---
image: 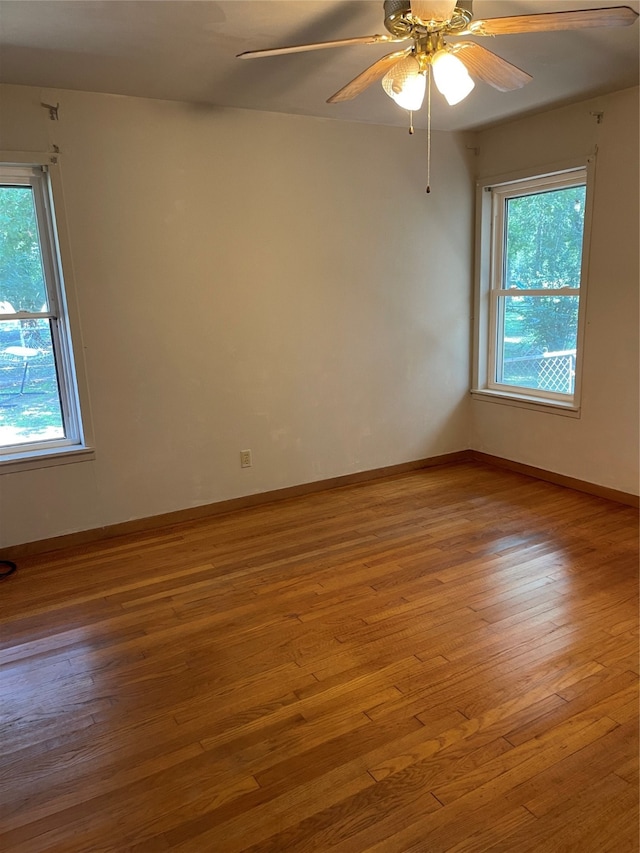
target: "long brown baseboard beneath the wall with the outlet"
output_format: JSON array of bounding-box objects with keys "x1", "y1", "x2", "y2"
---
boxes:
[{"x1": 0, "y1": 450, "x2": 471, "y2": 560}]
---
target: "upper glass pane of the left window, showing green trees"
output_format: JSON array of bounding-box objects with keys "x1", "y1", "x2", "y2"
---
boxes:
[{"x1": 0, "y1": 186, "x2": 47, "y2": 313}]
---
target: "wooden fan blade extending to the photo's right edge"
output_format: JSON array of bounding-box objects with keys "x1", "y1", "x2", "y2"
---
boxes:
[{"x1": 456, "y1": 6, "x2": 638, "y2": 36}]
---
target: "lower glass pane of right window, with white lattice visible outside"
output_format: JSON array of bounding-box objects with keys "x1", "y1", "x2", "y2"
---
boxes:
[{"x1": 496, "y1": 296, "x2": 579, "y2": 394}]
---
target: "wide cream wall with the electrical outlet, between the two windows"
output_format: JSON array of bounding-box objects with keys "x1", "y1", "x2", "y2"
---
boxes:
[{"x1": 0, "y1": 86, "x2": 473, "y2": 546}]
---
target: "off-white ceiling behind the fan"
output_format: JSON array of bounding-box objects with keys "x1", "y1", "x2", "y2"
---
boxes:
[{"x1": 0, "y1": 0, "x2": 640, "y2": 130}]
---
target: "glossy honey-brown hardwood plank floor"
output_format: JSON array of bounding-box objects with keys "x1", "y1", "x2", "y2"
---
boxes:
[{"x1": 0, "y1": 463, "x2": 638, "y2": 853}]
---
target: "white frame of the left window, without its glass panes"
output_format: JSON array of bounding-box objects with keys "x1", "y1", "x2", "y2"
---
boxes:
[{"x1": 0, "y1": 151, "x2": 94, "y2": 474}]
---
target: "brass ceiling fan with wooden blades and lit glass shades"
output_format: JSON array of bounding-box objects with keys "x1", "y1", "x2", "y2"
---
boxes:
[{"x1": 238, "y1": 0, "x2": 638, "y2": 111}]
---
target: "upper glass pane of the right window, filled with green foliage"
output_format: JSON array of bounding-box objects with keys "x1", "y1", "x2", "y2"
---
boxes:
[{"x1": 503, "y1": 186, "x2": 586, "y2": 290}]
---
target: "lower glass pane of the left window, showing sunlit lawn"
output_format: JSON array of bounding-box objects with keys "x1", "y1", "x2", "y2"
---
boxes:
[{"x1": 0, "y1": 319, "x2": 65, "y2": 447}]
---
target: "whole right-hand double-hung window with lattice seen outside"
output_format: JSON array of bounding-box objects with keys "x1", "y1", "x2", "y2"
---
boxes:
[{"x1": 474, "y1": 163, "x2": 589, "y2": 411}]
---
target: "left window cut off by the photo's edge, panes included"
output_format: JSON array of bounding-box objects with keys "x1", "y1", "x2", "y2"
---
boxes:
[{"x1": 0, "y1": 164, "x2": 90, "y2": 463}]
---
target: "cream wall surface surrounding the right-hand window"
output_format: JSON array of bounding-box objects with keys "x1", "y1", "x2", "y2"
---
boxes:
[{"x1": 471, "y1": 89, "x2": 640, "y2": 494}]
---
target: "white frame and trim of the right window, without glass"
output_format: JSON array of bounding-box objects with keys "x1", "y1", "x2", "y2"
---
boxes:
[{"x1": 471, "y1": 155, "x2": 595, "y2": 417}]
